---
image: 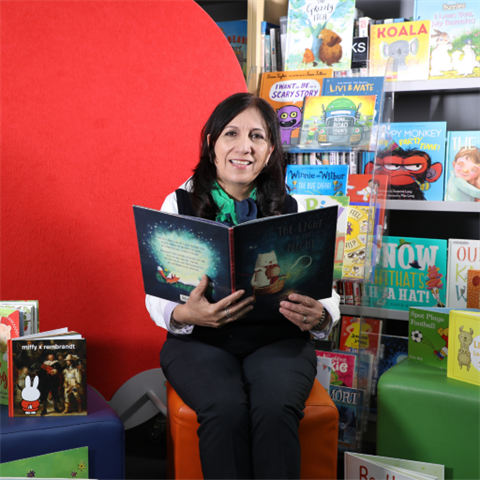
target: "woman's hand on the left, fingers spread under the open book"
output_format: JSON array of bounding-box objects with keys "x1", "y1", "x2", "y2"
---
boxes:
[{"x1": 172, "y1": 275, "x2": 253, "y2": 328}]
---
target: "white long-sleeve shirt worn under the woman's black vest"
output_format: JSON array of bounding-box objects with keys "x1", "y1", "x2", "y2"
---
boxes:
[{"x1": 145, "y1": 180, "x2": 340, "y2": 340}]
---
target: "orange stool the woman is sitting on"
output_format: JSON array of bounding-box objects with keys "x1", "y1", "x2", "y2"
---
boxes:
[{"x1": 167, "y1": 380, "x2": 338, "y2": 480}]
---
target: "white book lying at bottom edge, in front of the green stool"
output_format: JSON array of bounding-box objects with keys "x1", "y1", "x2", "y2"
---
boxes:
[{"x1": 344, "y1": 452, "x2": 445, "y2": 480}]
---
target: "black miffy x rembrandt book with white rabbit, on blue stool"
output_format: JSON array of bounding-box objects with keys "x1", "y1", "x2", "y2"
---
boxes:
[{"x1": 8, "y1": 328, "x2": 87, "y2": 418}]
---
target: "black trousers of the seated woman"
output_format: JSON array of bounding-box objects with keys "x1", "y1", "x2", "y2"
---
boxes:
[{"x1": 160, "y1": 335, "x2": 317, "y2": 480}]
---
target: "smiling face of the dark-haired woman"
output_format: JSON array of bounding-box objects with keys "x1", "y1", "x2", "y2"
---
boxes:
[{"x1": 210, "y1": 108, "x2": 273, "y2": 200}]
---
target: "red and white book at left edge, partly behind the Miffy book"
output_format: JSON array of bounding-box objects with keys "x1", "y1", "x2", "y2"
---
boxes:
[{"x1": 0, "y1": 306, "x2": 23, "y2": 405}]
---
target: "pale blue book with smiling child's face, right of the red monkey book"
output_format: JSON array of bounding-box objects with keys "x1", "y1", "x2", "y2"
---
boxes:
[{"x1": 444, "y1": 130, "x2": 480, "y2": 202}]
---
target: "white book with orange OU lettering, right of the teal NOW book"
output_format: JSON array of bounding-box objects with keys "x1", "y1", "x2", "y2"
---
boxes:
[{"x1": 447, "y1": 238, "x2": 480, "y2": 308}]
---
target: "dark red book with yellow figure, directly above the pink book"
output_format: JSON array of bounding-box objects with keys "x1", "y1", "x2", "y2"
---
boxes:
[{"x1": 338, "y1": 315, "x2": 382, "y2": 358}]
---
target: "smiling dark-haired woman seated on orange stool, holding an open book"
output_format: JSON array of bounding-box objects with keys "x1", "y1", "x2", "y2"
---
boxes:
[{"x1": 146, "y1": 93, "x2": 340, "y2": 480}]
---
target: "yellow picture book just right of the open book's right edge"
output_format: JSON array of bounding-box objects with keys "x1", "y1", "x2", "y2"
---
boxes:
[{"x1": 342, "y1": 205, "x2": 370, "y2": 280}]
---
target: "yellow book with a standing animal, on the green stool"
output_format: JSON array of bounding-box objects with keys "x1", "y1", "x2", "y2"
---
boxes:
[{"x1": 447, "y1": 310, "x2": 480, "y2": 386}]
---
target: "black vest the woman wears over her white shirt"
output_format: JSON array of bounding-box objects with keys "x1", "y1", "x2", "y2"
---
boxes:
[{"x1": 169, "y1": 189, "x2": 310, "y2": 356}]
